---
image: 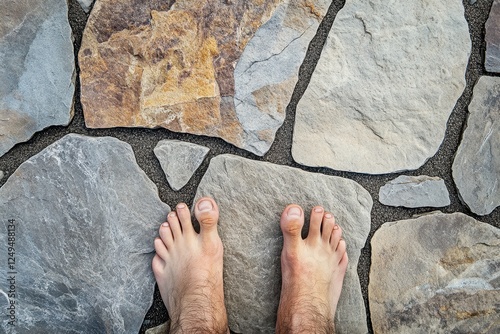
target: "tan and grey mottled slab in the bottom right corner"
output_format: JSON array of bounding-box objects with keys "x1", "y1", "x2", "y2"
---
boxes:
[{"x1": 368, "y1": 213, "x2": 500, "y2": 333}]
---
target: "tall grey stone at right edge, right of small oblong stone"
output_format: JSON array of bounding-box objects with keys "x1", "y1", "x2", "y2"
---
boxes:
[{"x1": 453, "y1": 77, "x2": 500, "y2": 215}]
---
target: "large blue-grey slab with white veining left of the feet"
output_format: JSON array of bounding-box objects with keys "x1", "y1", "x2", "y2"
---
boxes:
[{"x1": 0, "y1": 135, "x2": 169, "y2": 333}]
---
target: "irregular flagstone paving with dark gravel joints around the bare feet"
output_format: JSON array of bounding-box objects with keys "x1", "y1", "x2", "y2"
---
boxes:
[{"x1": 0, "y1": 0, "x2": 500, "y2": 333}]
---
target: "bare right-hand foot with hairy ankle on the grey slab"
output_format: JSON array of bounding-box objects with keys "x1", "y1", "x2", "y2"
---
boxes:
[{"x1": 276, "y1": 204, "x2": 348, "y2": 333}]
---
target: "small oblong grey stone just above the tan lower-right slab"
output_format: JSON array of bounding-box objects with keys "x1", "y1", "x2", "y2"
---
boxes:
[{"x1": 378, "y1": 175, "x2": 450, "y2": 208}]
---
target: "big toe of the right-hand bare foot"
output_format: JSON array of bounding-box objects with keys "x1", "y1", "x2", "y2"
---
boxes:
[{"x1": 280, "y1": 204, "x2": 304, "y2": 248}]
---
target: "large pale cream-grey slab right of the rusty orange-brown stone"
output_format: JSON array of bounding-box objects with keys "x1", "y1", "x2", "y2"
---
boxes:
[{"x1": 292, "y1": 0, "x2": 471, "y2": 174}]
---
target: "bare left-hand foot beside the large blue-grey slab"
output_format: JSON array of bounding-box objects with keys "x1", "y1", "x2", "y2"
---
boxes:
[{"x1": 153, "y1": 197, "x2": 229, "y2": 333}]
